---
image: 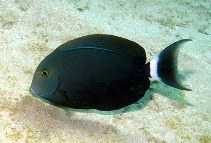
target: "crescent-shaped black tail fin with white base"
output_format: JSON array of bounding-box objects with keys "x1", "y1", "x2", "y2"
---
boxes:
[{"x1": 150, "y1": 39, "x2": 191, "y2": 90}]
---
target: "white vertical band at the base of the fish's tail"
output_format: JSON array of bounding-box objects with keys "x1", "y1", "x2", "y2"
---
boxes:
[{"x1": 150, "y1": 56, "x2": 161, "y2": 81}]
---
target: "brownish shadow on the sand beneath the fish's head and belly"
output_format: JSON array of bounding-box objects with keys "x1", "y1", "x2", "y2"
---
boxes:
[{"x1": 12, "y1": 95, "x2": 125, "y2": 142}]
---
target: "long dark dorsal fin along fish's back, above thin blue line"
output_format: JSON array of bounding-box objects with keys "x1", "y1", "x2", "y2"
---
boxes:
[{"x1": 55, "y1": 34, "x2": 146, "y2": 64}]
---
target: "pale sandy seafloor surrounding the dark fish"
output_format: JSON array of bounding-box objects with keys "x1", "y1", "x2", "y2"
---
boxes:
[{"x1": 0, "y1": 0, "x2": 211, "y2": 143}]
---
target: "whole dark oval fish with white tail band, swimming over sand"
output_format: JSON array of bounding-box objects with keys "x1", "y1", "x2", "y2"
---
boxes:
[{"x1": 29, "y1": 34, "x2": 191, "y2": 111}]
